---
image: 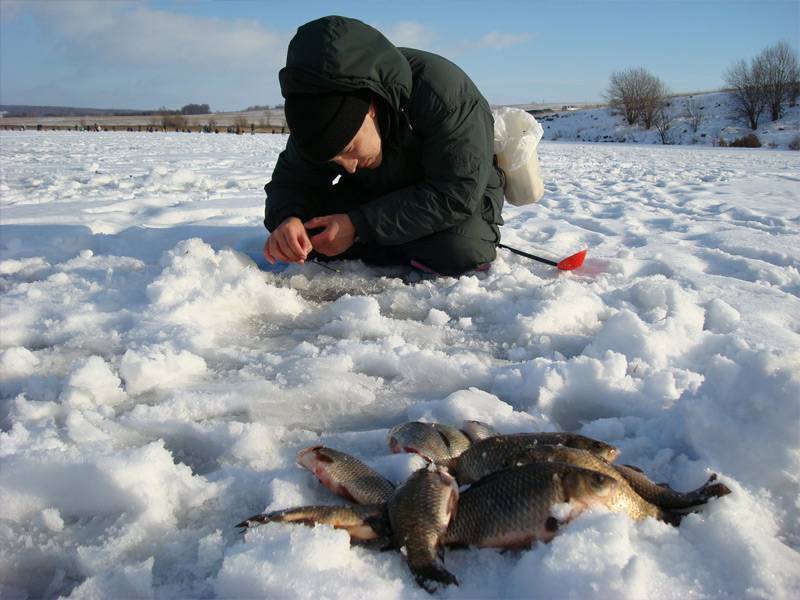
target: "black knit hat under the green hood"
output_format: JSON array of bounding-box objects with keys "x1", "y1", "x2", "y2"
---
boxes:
[{"x1": 284, "y1": 90, "x2": 372, "y2": 162}]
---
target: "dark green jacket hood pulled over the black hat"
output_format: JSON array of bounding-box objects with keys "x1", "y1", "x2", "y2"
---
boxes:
[{"x1": 278, "y1": 16, "x2": 412, "y2": 110}]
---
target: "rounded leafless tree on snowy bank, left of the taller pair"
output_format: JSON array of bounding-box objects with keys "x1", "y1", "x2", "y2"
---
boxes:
[{"x1": 606, "y1": 67, "x2": 667, "y2": 129}]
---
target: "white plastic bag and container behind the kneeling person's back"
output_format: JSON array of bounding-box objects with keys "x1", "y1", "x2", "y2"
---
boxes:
[{"x1": 492, "y1": 107, "x2": 544, "y2": 206}]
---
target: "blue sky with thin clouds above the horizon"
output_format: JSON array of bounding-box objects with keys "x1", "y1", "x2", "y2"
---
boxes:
[{"x1": 0, "y1": 0, "x2": 800, "y2": 110}]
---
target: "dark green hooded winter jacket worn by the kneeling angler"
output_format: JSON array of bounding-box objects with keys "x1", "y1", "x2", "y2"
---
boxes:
[{"x1": 264, "y1": 16, "x2": 503, "y2": 246}]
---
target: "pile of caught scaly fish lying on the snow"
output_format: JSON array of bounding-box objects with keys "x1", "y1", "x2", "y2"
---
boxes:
[{"x1": 238, "y1": 421, "x2": 730, "y2": 591}]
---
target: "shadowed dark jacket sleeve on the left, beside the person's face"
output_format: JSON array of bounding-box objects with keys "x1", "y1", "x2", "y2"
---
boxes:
[{"x1": 264, "y1": 136, "x2": 336, "y2": 231}]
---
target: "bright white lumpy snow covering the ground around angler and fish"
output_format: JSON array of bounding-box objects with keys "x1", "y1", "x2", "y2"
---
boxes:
[{"x1": 0, "y1": 132, "x2": 800, "y2": 600}]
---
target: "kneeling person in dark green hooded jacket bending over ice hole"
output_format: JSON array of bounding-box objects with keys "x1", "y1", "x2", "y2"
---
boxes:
[{"x1": 264, "y1": 17, "x2": 504, "y2": 275}]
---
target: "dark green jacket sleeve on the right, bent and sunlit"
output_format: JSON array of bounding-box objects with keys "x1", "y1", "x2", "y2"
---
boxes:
[{"x1": 348, "y1": 85, "x2": 494, "y2": 245}]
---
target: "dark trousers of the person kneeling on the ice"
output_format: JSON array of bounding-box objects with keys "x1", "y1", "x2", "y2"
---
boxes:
[{"x1": 319, "y1": 184, "x2": 500, "y2": 275}]
